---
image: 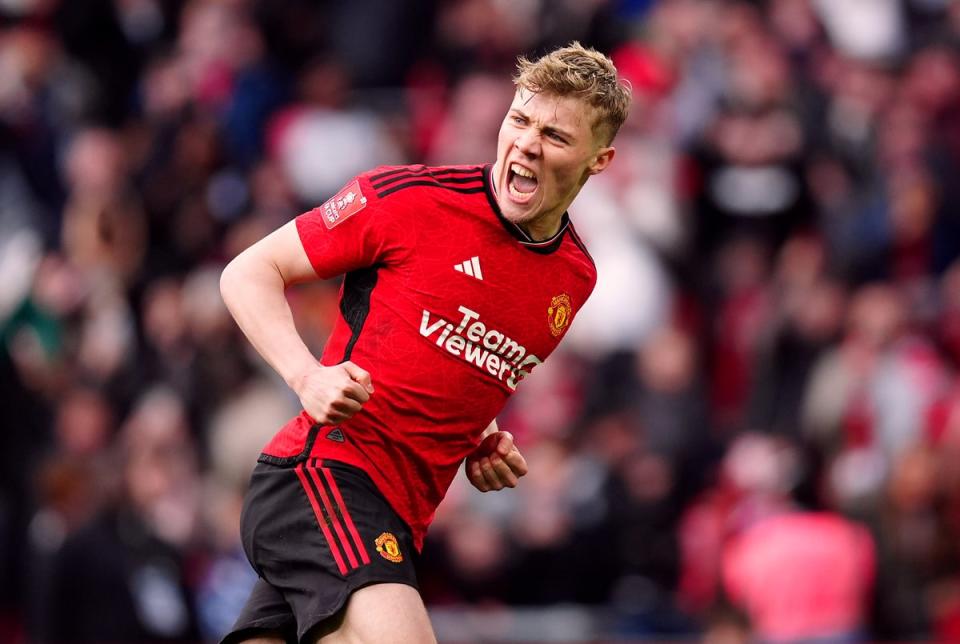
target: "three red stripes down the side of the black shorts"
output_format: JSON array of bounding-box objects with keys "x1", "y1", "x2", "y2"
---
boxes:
[{"x1": 295, "y1": 458, "x2": 370, "y2": 575}]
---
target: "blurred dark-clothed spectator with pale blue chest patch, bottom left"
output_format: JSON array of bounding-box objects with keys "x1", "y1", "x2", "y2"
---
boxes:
[{"x1": 41, "y1": 390, "x2": 198, "y2": 642}]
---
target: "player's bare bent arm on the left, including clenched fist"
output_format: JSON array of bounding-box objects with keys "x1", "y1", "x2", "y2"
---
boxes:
[{"x1": 220, "y1": 221, "x2": 373, "y2": 425}]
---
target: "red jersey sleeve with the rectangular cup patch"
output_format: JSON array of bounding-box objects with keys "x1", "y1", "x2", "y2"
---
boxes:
[{"x1": 296, "y1": 175, "x2": 399, "y2": 279}]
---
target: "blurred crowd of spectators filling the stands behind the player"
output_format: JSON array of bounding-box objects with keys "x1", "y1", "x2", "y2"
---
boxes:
[{"x1": 0, "y1": 0, "x2": 960, "y2": 643}]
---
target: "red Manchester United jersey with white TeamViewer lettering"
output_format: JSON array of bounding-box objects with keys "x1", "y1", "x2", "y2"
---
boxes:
[{"x1": 264, "y1": 165, "x2": 596, "y2": 548}]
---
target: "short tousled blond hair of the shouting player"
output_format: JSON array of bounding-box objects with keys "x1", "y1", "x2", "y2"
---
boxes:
[{"x1": 513, "y1": 41, "x2": 630, "y2": 145}]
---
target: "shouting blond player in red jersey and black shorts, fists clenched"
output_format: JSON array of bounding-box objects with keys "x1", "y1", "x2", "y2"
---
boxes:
[{"x1": 221, "y1": 43, "x2": 630, "y2": 644}]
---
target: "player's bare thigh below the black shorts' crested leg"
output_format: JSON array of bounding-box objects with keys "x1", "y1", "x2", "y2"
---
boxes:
[{"x1": 310, "y1": 584, "x2": 437, "y2": 644}]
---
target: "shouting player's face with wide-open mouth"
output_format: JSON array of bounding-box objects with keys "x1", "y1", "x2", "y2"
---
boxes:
[{"x1": 493, "y1": 88, "x2": 614, "y2": 239}]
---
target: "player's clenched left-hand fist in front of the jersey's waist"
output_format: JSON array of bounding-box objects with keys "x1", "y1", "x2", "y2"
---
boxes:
[{"x1": 294, "y1": 362, "x2": 373, "y2": 425}]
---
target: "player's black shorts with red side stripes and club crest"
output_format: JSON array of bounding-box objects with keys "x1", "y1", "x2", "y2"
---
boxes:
[{"x1": 222, "y1": 458, "x2": 417, "y2": 644}]
